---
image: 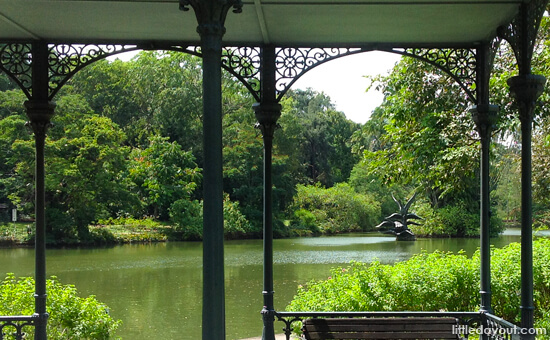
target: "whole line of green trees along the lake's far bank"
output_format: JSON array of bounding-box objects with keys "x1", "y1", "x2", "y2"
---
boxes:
[{"x1": 0, "y1": 18, "x2": 550, "y2": 241}]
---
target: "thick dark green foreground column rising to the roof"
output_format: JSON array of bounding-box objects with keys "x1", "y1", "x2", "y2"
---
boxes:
[{"x1": 180, "y1": 0, "x2": 242, "y2": 340}]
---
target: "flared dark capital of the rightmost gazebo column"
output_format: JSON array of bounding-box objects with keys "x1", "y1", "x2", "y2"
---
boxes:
[{"x1": 508, "y1": 74, "x2": 546, "y2": 123}]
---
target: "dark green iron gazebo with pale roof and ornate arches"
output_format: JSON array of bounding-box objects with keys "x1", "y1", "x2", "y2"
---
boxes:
[{"x1": 0, "y1": 0, "x2": 547, "y2": 340}]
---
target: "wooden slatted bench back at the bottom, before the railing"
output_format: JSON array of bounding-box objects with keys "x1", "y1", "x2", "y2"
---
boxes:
[{"x1": 302, "y1": 317, "x2": 461, "y2": 340}]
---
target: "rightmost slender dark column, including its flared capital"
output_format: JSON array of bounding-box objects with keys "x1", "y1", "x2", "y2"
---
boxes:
[{"x1": 508, "y1": 74, "x2": 546, "y2": 339}]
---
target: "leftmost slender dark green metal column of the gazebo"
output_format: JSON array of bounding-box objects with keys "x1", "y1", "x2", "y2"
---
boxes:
[{"x1": 25, "y1": 42, "x2": 55, "y2": 340}]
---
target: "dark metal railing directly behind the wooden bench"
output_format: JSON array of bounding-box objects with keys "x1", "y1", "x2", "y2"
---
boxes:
[{"x1": 275, "y1": 312, "x2": 484, "y2": 340}]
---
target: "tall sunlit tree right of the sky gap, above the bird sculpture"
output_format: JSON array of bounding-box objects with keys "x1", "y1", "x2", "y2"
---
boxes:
[{"x1": 356, "y1": 58, "x2": 479, "y2": 207}]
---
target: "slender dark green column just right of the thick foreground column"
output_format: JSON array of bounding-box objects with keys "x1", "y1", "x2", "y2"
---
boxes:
[{"x1": 254, "y1": 46, "x2": 281, "y2": 340}]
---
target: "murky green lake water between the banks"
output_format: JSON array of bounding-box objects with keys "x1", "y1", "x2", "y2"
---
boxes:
[{"x1": 0, "y1": 229, "x2": 544, "y2": 340}]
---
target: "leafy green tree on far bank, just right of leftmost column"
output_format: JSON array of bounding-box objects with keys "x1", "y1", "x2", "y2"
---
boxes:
[{"x1": 46, "y1": 95, "x2": 137, "y2": 240}]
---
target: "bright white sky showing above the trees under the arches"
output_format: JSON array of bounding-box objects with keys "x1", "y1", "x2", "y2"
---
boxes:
[{"x1": 109, "y1": 52, "x2": 401, "y2": 123}]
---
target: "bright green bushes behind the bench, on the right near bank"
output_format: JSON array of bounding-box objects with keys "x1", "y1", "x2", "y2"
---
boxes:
[{"x1": 287, "y1": 239, "x2": 550, "y2": 325}]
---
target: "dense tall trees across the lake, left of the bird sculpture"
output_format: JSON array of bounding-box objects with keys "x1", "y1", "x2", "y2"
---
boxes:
[{"x1": 0, "y1": 52, "x2": 366, "y2": 242}]
